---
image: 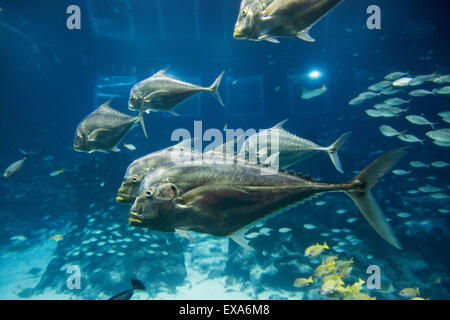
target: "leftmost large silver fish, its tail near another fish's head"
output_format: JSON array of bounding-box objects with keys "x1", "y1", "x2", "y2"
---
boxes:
[{"x1": 73, "y1": 100, "x2": 147, "y2": 153}]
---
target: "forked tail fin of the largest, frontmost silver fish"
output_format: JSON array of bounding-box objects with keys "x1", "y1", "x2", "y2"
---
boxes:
[{"x1": 346, "y1": 148, "x2": 406, "y2": 249}]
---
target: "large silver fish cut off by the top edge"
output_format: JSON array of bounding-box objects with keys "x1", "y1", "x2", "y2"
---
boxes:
[{"x1": 233, "y1": 0, "x2": 341, "y2": 43}]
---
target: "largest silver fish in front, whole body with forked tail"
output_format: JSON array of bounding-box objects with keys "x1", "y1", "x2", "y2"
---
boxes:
[{"x1": 128, "y1": 148, "x2": 406, "y2": 248}]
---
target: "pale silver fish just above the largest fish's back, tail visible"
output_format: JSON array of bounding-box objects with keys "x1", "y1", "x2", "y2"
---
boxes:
[{"x1": 238, "y1": 120, "x2": 350, "y2": 173}]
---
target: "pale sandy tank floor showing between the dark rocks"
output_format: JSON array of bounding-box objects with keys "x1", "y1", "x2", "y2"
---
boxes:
[{"x1": 0, "y1": 237, "x2": 303, "y2": 300}]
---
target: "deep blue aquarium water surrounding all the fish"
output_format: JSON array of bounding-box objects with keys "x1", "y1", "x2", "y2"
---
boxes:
[{"x1": 0, "y1": 0, "x2": 450, "y2": 299}]
